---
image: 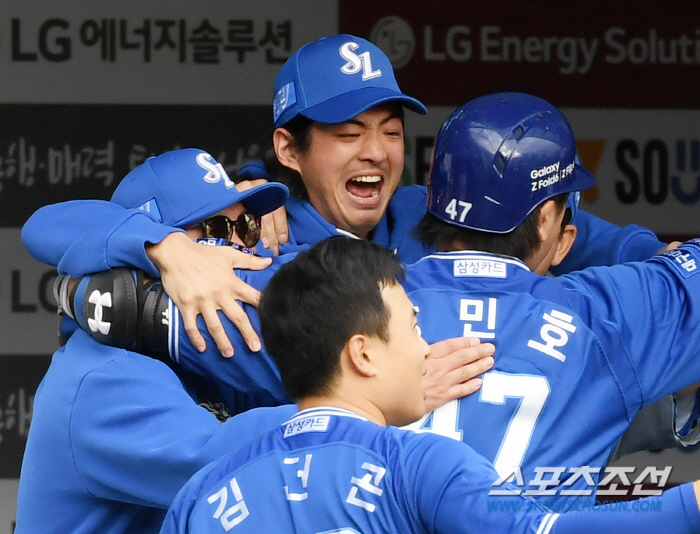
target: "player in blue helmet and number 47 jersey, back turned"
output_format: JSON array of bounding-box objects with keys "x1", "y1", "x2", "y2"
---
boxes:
[{"x1": 405, "y1": 93, "x2": 700, "y2": 500}]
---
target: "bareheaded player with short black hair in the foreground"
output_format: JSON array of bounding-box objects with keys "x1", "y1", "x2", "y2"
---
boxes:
[{"x1": 161, "y1": 239, "x2": 700, "y2": 534}]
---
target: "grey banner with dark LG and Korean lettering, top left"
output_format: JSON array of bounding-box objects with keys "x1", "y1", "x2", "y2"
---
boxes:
[{"x1": 0, "y1": 0, "x2": 337, "y2": 104}]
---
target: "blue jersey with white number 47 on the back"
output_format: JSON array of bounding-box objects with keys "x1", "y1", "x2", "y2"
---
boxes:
[{"x1": 405, "y1": 241, "x2": 700, "y2": 498}]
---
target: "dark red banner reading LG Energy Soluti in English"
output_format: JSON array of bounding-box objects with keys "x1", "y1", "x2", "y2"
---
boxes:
[{"x1": 340, "y1": 0, "x2": 700, "y2": 108}]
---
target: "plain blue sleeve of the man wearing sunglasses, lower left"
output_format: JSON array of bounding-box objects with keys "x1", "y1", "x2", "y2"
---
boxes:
[{"x1": 70, "y1": 340, "x2": 295, "y2": 508}]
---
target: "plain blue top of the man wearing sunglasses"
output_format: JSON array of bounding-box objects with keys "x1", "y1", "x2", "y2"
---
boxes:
[{"x1": 15, "y1": 330, "x2": 296, "y2": 534}]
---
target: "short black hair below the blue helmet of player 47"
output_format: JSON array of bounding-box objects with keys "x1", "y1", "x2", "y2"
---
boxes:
[{"x1": 415, "y1": 193, "x2": 571, "y2": 261}]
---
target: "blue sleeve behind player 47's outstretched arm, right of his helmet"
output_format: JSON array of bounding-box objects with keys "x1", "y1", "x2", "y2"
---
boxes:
[{"x1": 550, "y1": 210, "x2": 666, "y2": 275}]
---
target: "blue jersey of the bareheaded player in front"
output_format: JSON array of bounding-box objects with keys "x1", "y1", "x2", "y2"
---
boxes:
[{"x1": 161, "y1": 407, "x2": 700, "y2": 534}]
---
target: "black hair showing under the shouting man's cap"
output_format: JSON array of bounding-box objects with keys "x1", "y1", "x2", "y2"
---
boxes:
[{"x1": 265, "y1": 101, "x2": 405, "y2": 201}]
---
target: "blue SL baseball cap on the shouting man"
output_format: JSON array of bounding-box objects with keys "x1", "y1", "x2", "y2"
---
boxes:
[{"x1": 272, "y1": 34, "x2": 428, "y2": 128}]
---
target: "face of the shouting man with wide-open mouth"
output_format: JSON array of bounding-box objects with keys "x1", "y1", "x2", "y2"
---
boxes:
[{"x1": 278, "y1": 104, "x2": 404, "y2": 238}]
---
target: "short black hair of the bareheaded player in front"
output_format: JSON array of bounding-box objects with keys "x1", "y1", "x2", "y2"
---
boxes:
[{"x1": 258, "y1": 236, "x2": 404, "y2": 401}]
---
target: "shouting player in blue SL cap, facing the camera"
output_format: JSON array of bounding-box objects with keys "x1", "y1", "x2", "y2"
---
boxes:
[{"x1": 24, "y1": 35, "x2": 426, "y2": 355}]
